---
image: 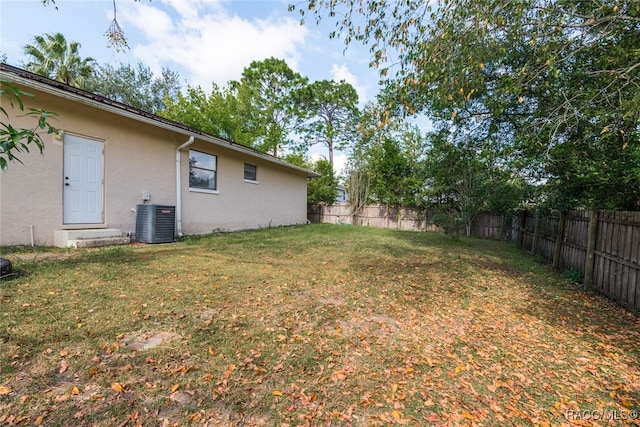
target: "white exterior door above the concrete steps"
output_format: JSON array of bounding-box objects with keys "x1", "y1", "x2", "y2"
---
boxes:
[{"x1": 63, "y1": 135, "x2": 104, "y2": 224}]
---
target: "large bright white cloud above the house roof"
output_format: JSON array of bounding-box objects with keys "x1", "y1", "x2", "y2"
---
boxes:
[{"x1": 122, "y1": 0, "x2": 309, "y2": 90}]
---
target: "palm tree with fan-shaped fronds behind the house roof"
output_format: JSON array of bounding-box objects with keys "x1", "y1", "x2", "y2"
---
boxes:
[{"x1": 24, "y1": 33, "x2": 95, "y2": 88}]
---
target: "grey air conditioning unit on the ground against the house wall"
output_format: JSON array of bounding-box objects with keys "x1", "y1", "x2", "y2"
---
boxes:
[{"x1": 136, "y1": 205, "x2": 176, "y2": 243}]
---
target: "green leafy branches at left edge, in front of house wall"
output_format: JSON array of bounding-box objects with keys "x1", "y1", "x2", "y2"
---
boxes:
[{"x1": 0, "y1": 81, "x2": 56, "y2": 172}]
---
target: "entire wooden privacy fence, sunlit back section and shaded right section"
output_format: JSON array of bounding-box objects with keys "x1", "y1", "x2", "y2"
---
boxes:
[{"x1": 308, "y1": 203, "x2": 640, "y2": 313}]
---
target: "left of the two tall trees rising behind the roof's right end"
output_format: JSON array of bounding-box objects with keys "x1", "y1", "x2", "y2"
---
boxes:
[{"x1": 230, "y1": 58, "x2": 307, "y2": 156}]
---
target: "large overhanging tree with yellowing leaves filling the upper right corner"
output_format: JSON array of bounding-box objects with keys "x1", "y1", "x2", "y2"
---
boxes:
[{"x1": 292, "y1": 0, "x2": 640, "y2": 211}]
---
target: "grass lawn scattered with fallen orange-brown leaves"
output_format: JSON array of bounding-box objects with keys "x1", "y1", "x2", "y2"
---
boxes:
[{"x1": 0, "y1": 224, "x2": 640, "y2": 426}]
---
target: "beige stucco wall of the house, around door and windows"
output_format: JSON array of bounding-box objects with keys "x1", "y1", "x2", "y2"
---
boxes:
[{"x1": 0, "y1": 82, "x2": 306, "y2": 245}]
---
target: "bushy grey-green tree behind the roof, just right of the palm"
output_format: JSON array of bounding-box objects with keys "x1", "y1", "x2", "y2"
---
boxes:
[{"x1": 87, "y1": 62, "x2": 180, "y2": 114}]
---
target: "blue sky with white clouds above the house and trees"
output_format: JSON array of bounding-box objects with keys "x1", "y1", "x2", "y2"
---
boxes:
[{"x1": 0, "y1": 0, "x2": 378, "y2": 172}]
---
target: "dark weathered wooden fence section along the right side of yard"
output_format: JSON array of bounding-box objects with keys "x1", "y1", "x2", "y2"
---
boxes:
[{"x1": 514, "y1": 211, "x2": 640, "y2": 313}]
